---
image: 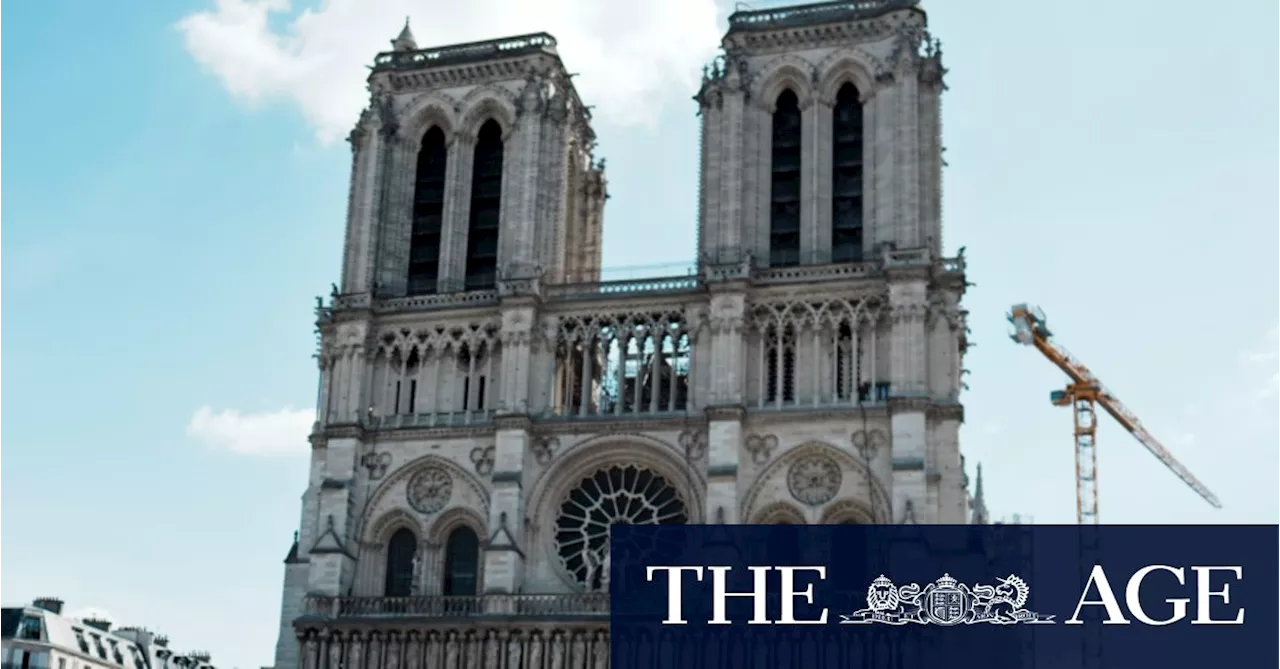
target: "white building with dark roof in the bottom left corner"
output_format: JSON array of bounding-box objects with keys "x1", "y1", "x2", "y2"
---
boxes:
[{"x1": 0, "y1": 597, "x2": 214, "y2": 669}]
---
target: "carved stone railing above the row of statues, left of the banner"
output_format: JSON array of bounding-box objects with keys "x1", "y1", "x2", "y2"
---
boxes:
[{"x1": 303, "y1": 592, "x2": 609, "y2": 619}]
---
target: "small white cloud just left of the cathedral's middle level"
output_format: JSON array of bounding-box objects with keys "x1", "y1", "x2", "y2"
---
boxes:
[{"x1": 187, "y1": 407, "x2": 315, "y2": 455}]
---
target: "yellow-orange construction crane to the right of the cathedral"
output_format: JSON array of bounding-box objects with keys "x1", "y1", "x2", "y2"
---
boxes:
[{"x1": 1009, "y1": 304, "x2": 1222, "y2": 524}]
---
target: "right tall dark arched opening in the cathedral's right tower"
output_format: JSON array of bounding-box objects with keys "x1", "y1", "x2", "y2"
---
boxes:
[{"x1": 831, "y1": 83, "x2": 863, "y2": 262}]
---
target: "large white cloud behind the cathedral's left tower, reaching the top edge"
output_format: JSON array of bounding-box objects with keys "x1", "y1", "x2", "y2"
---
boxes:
[{"x1": 177, "y1": 0, "x2": 722, "y2": 142}]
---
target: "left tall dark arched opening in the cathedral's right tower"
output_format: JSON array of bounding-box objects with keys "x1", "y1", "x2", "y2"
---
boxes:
[{"x1": 769, "y1": 88, "x2": 800, "y2": 267}]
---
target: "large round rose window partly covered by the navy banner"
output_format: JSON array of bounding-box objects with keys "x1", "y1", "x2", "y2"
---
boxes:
[{"x1": 556, "y1": 464, "x2": 689, "y2": 586}]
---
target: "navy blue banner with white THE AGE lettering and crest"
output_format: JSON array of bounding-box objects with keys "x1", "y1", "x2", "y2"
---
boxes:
[{"x1": 609, "y1": 524, "x2": 1280, "y2": 669}]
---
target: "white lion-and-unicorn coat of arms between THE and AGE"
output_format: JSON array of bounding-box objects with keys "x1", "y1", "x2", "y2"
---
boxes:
[{"x1": 841, "y1": 574, "x2": 1053, "y2": 627}]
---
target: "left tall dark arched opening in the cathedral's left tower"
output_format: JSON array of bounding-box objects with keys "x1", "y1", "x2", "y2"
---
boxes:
[{"x1": 408, "y1": 125, "x2": 448, "y2": 295}]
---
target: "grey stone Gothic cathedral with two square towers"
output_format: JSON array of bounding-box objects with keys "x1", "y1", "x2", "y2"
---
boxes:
[{"x1": 275, "y1": 0, "x2": 986, "y2": 669}]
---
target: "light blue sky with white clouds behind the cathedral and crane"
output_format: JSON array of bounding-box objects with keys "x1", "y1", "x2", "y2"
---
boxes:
[{"x1": 0, "y1": 0, "x2": 1280, "y2": 668}]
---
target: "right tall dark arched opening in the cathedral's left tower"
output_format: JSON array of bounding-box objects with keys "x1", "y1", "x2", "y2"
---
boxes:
[{"x1": 466, "y1": 119, "x2": 502, "y2": 290}]
